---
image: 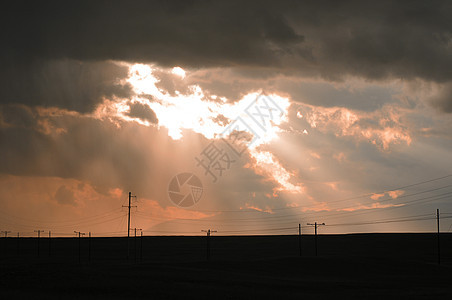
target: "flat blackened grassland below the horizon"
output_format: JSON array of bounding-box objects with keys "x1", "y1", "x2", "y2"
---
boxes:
[{"x1": 0, "y1": 233, "x2": 452, "y2": 299}]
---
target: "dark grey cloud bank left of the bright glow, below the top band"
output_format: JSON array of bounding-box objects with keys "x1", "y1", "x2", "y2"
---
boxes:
[{"x1": 0, "y1": 59, "x2": 131, "y2": 112}]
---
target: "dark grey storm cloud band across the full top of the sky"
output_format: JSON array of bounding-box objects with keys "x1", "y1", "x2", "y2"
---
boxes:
[{"x1": 1, "y1": 1, "x2": 452, "y2": 81}]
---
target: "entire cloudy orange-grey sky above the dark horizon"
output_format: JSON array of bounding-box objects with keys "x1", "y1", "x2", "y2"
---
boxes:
[{"x1": 0, "y1": 1, "x2": 452, "y2": 236}]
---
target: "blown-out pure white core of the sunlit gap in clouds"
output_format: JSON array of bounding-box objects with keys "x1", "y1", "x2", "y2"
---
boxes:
[{"x1": 128, "y1": 64, "x2": 290, "y2": 147}]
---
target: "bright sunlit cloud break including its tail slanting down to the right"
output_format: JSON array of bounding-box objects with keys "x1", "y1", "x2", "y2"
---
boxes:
[{"x1": 119, "y1": 64, "x2": 302, "y2": 193}]
